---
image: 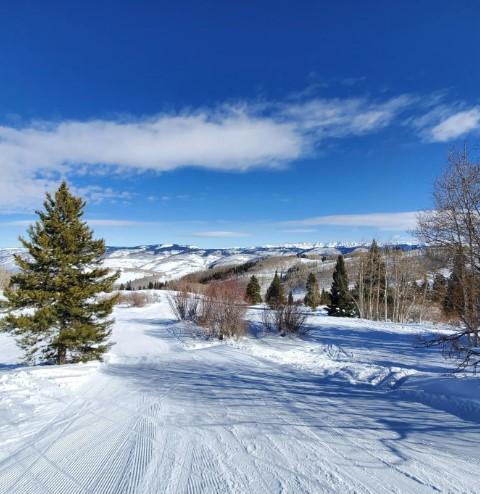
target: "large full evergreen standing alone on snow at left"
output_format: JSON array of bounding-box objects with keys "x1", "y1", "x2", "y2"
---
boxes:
[{"x1": 2, "y1": 182, "x2": 118, "y2": 364}]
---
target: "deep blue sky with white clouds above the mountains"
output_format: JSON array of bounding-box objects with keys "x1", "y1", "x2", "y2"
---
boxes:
[{"x1": 0, "y1": 0, "x2": 480, "y2": 247}]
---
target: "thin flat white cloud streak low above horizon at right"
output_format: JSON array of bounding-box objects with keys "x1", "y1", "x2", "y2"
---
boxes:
[{"x1": 283, "y1": 211, "x2": 418, "y2": 231}]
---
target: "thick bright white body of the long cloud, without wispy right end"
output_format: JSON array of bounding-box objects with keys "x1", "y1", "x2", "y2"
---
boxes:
[{"x1": 0, "y1": 110, "x2": 302, "y2": 171}]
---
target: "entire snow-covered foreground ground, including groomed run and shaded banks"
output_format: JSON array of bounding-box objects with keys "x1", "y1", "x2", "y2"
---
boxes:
[{"x1": 0, "y1": 294, "x2": 480, "y2": 494}]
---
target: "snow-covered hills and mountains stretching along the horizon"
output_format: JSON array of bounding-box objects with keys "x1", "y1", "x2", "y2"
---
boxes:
[{"x1": 0, "y1": 242, "x2": 420, "y2": 283}]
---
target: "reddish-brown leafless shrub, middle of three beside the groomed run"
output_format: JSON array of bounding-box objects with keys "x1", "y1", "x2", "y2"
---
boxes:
[{"x1": 198, "y1": 280, "x2": 247, "y2": 339}]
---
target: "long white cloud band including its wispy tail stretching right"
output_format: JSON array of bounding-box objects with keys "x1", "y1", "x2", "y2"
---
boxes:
[{"x1": 0, "y1": 96, "x2": 411, "y2": 213}]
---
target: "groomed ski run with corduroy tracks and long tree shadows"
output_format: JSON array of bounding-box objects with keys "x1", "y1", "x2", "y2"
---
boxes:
[{"x1": 0, "y1": 300, "x2": 480, "y2": 494}]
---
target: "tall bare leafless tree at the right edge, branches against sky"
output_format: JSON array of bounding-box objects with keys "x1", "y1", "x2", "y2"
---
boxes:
[{"x1": 416, "y1": 146, "x2": 480, "y2": 370}]
